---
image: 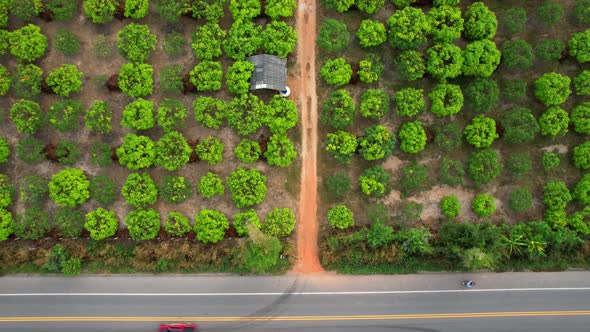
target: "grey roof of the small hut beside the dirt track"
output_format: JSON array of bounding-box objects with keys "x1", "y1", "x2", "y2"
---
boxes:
[{"x1": 246, "y1": 54, "x2": 287, "y2": 91}]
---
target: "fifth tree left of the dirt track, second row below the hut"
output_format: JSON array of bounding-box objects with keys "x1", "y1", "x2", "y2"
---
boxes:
[{"x1": 116, "y1": 134, "x2": 156, "y2": 171}]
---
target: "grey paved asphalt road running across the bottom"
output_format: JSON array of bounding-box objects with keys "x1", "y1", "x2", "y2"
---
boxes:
[{"x1": 0, "y1": 272, "x2": 590, "y2": 332}]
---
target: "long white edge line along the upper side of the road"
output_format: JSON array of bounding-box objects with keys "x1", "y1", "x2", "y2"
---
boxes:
[{"x1": 0, "y1": 287, "x2": 590, "y2": 297}]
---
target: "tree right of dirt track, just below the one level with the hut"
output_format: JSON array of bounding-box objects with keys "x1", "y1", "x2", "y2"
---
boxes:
[{"x1": 320, "y1": 89, "x2": 356, "y2": 129}]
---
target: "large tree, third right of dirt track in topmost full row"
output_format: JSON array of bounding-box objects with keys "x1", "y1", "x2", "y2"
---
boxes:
[{"x1": 387, "y1": 7, "x2": 431, "y2": 50}]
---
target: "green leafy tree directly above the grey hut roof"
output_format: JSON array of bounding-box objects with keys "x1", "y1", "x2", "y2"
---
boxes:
[{"x1": 264, "y1": 20, "x2": 297, "y2": 58}]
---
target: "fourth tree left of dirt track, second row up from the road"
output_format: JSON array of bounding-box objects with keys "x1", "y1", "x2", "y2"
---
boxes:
[{"x1": 121, "y1": 173, "x2": 158, "y2": 208}]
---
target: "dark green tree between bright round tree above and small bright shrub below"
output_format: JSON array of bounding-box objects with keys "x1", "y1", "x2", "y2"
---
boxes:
[{"x1": 467, "y1": 149, "x2": 502, "y2": 186}]
